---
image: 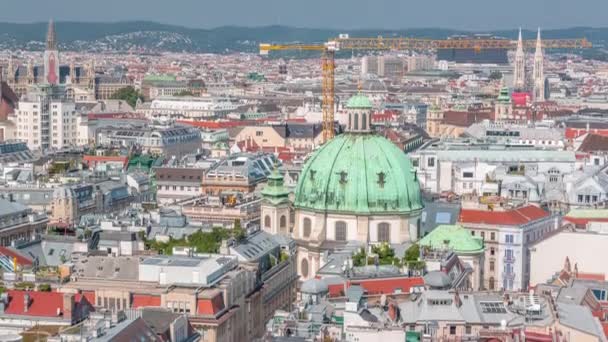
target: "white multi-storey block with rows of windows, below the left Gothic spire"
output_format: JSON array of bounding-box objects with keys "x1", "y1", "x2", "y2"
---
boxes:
[{"x1": 12, "y1": 85, "x2": 79, "y2": 150}]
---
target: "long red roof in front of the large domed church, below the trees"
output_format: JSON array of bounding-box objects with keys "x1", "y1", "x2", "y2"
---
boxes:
[{"x1": 328, "y1": 276, "x2": 424, "y2": 297}]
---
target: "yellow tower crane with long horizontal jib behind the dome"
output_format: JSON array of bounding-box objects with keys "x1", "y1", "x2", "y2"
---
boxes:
[{"x1": 260, "y1": 34, "x2": 591, "y2": 142}]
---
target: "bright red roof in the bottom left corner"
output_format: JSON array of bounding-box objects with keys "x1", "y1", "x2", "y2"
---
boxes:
[{"x1": 4, "y1": 290, "x2": 63, "y2": 317}]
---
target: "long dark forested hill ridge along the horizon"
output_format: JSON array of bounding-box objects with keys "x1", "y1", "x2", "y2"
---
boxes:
[{"x1": 0, "y1": 21, "x2": 608, "y2": 53}]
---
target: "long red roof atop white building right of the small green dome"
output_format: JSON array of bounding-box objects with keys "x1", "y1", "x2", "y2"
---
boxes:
[{"x1": 458, "y1": 205, "x2": 550, "y2": 226}]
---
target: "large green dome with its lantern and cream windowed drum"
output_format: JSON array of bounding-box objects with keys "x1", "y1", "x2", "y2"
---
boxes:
[{"x1": 293, "y1": 94, "x2": 423, "y2": 280}]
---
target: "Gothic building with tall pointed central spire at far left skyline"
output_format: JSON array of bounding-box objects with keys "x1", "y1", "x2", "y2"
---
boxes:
[{"x1": 3, "y1": 20, "x2": 95, "y2": 102}]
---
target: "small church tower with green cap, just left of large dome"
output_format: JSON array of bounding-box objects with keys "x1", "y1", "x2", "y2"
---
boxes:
[{"x1": 261, "y1": 168, "x2": 291, "y2": 234}]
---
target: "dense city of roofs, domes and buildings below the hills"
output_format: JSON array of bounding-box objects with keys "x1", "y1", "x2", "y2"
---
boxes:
[{"x1": 0, "y1": 12, "x2": 608, "y2": 342}]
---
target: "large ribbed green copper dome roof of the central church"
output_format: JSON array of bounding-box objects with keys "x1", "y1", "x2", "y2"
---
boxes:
[{"x1": 294, "y1": 133, "x2": 423, "y2": 214}]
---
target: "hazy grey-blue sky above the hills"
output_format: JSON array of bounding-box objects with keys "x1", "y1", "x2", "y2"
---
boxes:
[{"x1": 0, "y1": 0, "x2": 608, "y2": 30}]
